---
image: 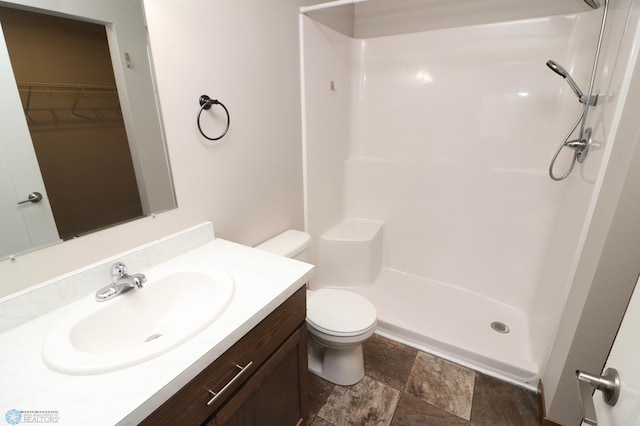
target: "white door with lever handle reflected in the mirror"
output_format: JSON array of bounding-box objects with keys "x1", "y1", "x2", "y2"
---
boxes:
[{"x1": 0, "y1": 21, "x2": 60, "y2": 258}]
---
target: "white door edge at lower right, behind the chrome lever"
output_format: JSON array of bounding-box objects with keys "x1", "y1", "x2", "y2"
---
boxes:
[{"x1": 582, "y1": 274, "x2": 640, "y2": 426}]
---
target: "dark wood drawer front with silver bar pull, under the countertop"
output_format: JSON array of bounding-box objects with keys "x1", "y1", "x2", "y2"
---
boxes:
[{"x1": 141, "y1": 287, "x2": 306, "y2": 426}]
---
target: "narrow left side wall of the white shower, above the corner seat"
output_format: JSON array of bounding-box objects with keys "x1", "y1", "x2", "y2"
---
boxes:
[{"x1": 301, "y1": 16, "x2": 352, "y2": 266}]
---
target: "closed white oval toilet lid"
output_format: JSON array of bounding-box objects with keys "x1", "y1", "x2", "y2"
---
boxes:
[{"x1": 307, "y1": 288, "x2": 376, "y2": 335}]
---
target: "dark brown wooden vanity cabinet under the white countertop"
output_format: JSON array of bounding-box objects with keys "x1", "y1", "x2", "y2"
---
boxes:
[{"x1": 141, "y1": 287, "x2": 309, "y2": 426}]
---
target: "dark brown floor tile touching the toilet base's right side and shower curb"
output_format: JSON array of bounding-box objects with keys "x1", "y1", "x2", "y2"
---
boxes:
[{"x1": 362, "y1": 334, "x2": 418, "y2": 390}]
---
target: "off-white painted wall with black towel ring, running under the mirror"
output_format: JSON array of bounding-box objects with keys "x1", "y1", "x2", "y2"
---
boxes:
[{"x1": 0, "y1": 0, "x2": 303, "y2": 298}]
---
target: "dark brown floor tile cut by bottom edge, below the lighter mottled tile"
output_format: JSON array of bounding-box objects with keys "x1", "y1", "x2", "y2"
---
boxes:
[{"x1": 391, "y1": 393, "x2": 469, "y2": 426}]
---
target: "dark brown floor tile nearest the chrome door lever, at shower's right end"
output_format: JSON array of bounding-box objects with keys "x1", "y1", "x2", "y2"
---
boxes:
[{"x1": 471, "y1": 373, "x2": 540, "y2": 426}]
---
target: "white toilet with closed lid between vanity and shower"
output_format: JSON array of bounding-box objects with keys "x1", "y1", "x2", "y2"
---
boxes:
[{"x1": 256, "y1": 230, "x2": 377, "y2": 386}]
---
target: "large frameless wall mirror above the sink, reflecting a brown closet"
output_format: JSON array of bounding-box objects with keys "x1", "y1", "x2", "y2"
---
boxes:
[{"x1": 0, "y1": 0, "x2": 176, "y2": 259}]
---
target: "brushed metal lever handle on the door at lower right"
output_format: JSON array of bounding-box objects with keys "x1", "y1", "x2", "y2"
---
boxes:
[{"x1": 576, "y1": 368, "x2": 620, "y2": 426}]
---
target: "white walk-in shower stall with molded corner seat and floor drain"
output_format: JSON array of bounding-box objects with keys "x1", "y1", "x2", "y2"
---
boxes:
[{"x1": 300, "y1": 0, "x2": 638, "y2": 388}]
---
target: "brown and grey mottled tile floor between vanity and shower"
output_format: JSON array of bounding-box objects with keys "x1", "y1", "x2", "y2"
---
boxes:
[{"x1": 308, "y1": 335, "x2": 540, "y2": 426}]
